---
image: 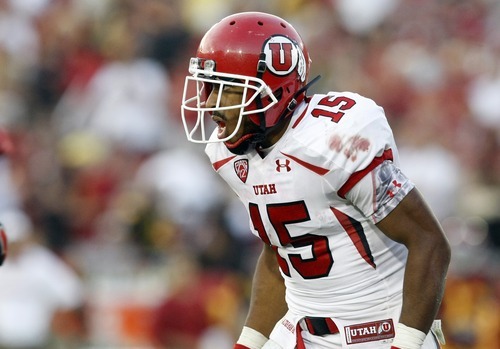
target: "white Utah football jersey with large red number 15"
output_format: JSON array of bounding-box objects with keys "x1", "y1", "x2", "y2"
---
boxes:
[{"x1": 206, "y1": 92, "x2": 413, "y2": 323}]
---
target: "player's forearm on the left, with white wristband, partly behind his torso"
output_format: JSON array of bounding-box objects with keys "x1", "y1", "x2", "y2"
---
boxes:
[{"x1": 235, "y1": 245, "x2": 288, "y2": 349}]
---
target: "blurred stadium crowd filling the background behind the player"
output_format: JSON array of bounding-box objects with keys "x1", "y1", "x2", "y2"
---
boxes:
[{"x1": 0, "y1": 0, "x2": 500, "y2": 349}]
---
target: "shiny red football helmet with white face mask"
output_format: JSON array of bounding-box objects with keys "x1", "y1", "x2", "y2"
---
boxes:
[{"x1": 181, "y1": 12, "x2": 310, "y2": 143}]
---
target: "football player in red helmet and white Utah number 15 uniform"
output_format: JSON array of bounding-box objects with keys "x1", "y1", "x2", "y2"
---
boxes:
[{"x1": 181, "y1": 12, "x2": 450, "y2": 349}]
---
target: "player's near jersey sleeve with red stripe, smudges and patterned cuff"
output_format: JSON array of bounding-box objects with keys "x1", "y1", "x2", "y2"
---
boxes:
[{"x1": 310, "y1": 93, "x2": 414, "y2": 222}]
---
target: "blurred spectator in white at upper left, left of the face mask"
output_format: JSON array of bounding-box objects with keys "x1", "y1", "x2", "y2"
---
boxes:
[{"x1": 55, "y1": 8, "x2": 174, "y2": 153}]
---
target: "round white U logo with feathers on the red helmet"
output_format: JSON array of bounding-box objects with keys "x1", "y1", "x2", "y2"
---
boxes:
[{"x1": 264, "y1": 35, "x2": 306, "y2": 81}]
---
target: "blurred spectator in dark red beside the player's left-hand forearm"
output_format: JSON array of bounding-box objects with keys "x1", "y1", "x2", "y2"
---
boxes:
[{"x1": 152, "y1": 254, "x2": 243, "y2": 349}]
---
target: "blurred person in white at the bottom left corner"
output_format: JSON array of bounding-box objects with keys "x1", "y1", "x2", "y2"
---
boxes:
[{"x1": 0, "y1": 210, "x2": 85, "y2": 349}]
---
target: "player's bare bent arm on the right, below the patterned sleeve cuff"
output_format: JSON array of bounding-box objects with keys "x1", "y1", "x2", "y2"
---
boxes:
[{"x1": 377, "y1": 189, "x2": 451, "y2": 344}]
